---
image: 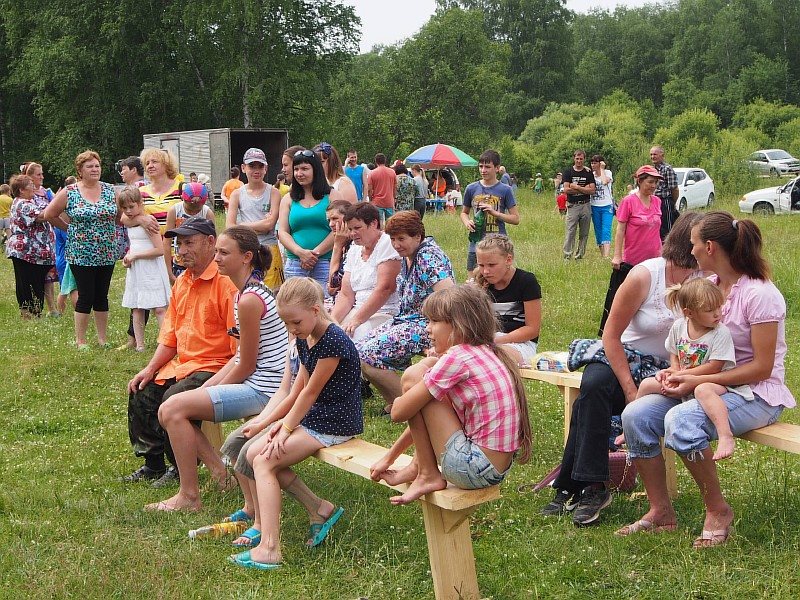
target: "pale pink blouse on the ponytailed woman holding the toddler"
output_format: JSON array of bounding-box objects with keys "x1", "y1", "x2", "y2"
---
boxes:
[{"x1": 710, "y1": 275, "x2": 796, "y2": 408}]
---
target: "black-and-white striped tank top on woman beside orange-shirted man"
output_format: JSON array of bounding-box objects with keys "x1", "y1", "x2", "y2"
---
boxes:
[{"x1": 233, "y1": 282, "x2": 289, "y2": 396}]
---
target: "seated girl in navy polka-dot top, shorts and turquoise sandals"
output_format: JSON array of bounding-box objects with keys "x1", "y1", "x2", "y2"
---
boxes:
[{"x1": 229, "y1": 277, "x2": 364, "y2": 570}]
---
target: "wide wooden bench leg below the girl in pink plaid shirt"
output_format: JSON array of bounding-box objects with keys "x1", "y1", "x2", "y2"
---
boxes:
[{"x1": 420, "y1": 502, "x2": 480, "y2": 600}]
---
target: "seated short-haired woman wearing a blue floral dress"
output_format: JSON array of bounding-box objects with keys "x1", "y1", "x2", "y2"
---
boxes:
[{"x1": 356, "y1": 210, "x2": 455, "y2": 413}]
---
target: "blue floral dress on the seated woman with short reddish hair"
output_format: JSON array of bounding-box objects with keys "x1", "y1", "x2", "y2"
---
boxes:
[{"x1": 356, "y1": 238, "x2": 455, "y2": 371}]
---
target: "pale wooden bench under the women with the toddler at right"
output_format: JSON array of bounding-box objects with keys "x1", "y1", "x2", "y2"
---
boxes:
[{"x1": 520, "y1": 369, "x2": 800, "y2": 498}]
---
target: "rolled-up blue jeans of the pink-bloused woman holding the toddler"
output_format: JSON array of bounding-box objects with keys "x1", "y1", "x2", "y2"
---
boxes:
[{"x1": 622, "y1": 392, "x2": 783, "y2": 460}]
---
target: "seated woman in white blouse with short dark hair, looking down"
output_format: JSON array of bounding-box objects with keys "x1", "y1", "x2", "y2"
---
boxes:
[{"x1": 331, "y1": 202, "x2": 401, "y2": 341}]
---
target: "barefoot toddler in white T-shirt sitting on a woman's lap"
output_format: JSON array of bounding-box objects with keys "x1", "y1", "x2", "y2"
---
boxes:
[{"x1": 636, "y1": 278, "x2": 754, "y2": 460}]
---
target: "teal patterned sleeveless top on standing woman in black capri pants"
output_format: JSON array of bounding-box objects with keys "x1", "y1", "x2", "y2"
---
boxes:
[{"x1": 65, "y1": 182, "x2": 117, "y2": 267}]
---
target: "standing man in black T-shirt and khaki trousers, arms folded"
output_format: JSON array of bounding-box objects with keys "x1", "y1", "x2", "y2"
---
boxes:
[{"x1": 562, "y1": 150, "x2": 595, "y2": 260}]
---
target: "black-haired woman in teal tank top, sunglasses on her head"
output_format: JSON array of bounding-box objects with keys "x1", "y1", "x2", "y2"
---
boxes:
[{"x1": 278, "y1": 150, "x2": 342, "y2": 289}]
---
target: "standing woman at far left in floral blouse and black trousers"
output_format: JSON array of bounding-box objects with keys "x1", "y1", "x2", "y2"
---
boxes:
[{"x1": 6, "y1": 175, "x2": 55, "y2": 319}]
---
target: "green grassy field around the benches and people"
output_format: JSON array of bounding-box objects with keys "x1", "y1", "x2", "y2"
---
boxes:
[{"x1": 0, "y1": 191, "x2": 800, "y2": 600}]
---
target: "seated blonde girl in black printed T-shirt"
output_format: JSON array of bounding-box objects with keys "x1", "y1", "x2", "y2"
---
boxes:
[{"x1": 475, "y1": 233, "x2": 542, "y2": 366}]
